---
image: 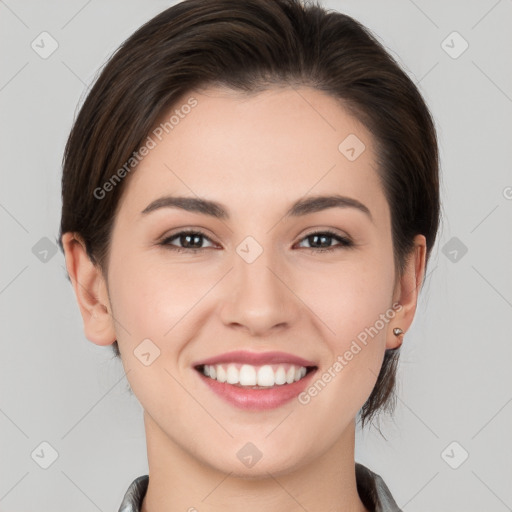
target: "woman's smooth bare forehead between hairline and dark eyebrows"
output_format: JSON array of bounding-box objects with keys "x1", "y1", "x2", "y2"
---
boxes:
[{"x1": 116, "y1": 87, "x2": 385, "y2": 223}]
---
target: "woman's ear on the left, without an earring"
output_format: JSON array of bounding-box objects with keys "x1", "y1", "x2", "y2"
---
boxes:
[{"x1": 62, "y1": 232, "x2": 116, "y2": 345}]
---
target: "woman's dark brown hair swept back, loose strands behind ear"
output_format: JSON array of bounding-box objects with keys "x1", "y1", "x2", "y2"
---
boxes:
[{"x1": 58, "y1": 0, "x2": 440, "y2": 427}]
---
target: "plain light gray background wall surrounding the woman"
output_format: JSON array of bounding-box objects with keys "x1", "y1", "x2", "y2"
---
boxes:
[{"x1": 0, "y1": 0, "x2": 512, "y2": 512}]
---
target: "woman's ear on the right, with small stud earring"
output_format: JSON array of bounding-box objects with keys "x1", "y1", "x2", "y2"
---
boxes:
[{"x1": 386, "y1": 235, "x2": 427, "y2": 349}]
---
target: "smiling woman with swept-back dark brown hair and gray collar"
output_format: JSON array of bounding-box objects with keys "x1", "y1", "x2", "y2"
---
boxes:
[{"x1": 60, "y1": 0, "x2": 439, "y2": 512}]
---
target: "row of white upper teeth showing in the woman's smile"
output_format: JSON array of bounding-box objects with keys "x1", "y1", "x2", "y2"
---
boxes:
[{"x1": 203, "y1": 363, "x2": 307, "y2": 387}]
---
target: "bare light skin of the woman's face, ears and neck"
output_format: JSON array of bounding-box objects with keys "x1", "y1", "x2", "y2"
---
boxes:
[{"x1": 63, "y1": 87, "x2": 425, "y2": 512}]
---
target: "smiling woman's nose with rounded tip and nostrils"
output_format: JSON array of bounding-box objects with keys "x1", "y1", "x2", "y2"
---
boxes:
[{"x1": 220, "y1": 250, "x2": 301, "y2": 337}]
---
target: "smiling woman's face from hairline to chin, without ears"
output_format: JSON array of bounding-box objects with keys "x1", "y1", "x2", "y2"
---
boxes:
[{"x1": 83, "y1": 88, "x2": 420, "y2": 476}]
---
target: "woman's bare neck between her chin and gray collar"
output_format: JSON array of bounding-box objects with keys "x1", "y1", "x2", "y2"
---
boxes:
[{"x1": 141, "y1": 413, "x2": 367, "y2": 512}]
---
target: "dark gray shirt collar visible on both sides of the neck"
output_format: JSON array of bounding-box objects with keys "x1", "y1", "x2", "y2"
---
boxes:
[{"x1": 119, "y1": 462, "x2": 402, "y2": 512}]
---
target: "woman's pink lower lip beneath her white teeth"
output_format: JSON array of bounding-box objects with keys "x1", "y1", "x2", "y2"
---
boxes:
[{"x1": 194, "y1": 368, "x2": 317, "y2": 411}]
